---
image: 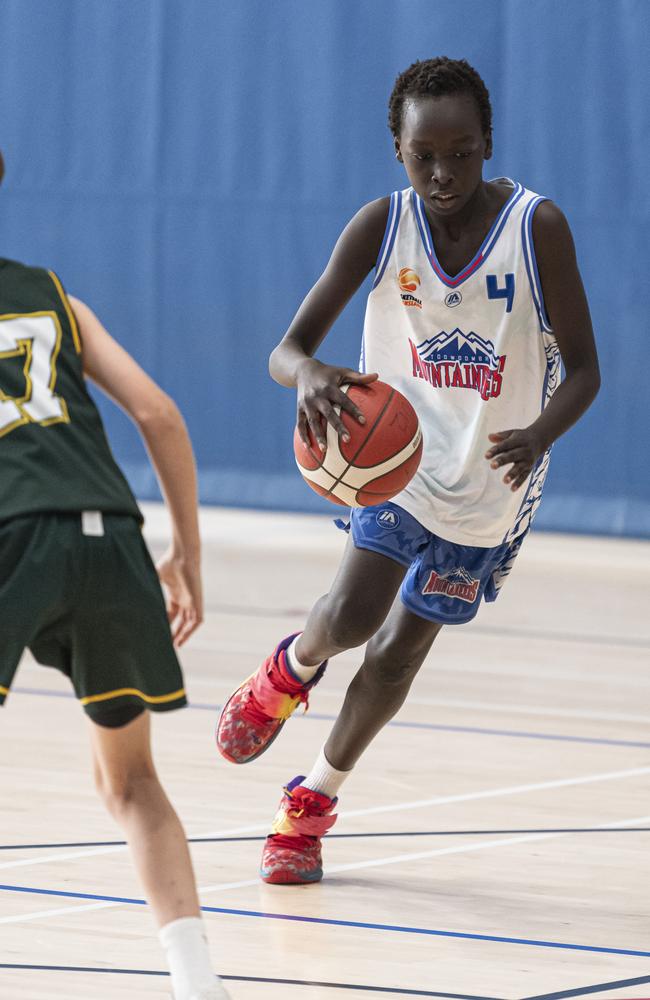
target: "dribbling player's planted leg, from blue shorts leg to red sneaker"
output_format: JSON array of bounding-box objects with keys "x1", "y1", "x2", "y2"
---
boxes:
[{"x1": 262, "y1": 535, "x2": 520, "y2": 882}]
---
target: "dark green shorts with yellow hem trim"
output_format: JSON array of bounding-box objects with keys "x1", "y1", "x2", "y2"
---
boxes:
[{"x1": 0, "y1": 514, "x2": 187, "y2": 721}]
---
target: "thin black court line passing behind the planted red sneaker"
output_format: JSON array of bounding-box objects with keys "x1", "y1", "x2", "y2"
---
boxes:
[{"x1": 0, "y1": 826, "x2": 650, "y2": 851}]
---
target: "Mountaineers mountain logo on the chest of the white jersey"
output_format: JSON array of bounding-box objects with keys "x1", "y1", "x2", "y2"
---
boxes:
[{"x1": 409, "y1": 327, "x2": 506, "y2": 400}]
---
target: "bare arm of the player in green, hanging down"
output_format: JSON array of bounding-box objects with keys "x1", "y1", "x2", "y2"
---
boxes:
[{"x1": 70, "y1": 297, "x2": 203, "y2": 646}]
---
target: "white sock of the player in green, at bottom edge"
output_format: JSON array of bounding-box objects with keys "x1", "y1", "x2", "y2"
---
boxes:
[{"x1": 158, "y1": 917, "x2": 227, "y2": 1000}]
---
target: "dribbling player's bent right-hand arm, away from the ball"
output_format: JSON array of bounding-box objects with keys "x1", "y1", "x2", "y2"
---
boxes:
[{"x1": 485, "y1": 201, "x2": 600, "y2": 490}]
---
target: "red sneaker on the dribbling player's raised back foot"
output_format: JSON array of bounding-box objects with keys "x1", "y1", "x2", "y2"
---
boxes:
[{"x1": 216, "y1": 632, "x2": 327, "y2": 764}]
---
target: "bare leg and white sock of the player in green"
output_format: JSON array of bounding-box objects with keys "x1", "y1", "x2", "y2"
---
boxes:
[{"x1": 90, "y1": 709, "x2": 227, "y2": 1000}]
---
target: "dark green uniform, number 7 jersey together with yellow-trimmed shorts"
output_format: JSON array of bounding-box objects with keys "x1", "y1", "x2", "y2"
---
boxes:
[{"x1": 0, "y1": 258, "x2": 186, "y2": 721}]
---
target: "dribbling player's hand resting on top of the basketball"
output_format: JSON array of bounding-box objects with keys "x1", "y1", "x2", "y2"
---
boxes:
[{"x1": 296, "y1": 358, "x2": 379, "y2": 451}]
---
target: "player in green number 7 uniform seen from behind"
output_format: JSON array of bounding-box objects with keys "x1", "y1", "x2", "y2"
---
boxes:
[{"x1": 0, "y1": 157, "x2": 226, "y2": 1000}]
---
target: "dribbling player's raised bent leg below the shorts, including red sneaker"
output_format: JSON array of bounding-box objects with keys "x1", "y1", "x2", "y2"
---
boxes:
[{"x1": 217, "y1": 538, "x2": 406, "y2": 764}]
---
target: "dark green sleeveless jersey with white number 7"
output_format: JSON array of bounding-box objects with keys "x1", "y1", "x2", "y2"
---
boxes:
[{"x1": 0, "y1": 258, "x2": 141, "y2": 521}]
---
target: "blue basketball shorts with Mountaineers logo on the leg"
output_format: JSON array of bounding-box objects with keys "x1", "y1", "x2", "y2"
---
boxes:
[{"x1": 350, "y1": 503, "x2": 523, "y2": 625}]
